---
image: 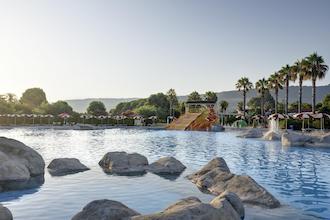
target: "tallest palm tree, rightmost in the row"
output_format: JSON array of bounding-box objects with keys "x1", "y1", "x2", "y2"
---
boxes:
[{"x1": 306, "y1": 53, "x2": 329, "y2": 113}]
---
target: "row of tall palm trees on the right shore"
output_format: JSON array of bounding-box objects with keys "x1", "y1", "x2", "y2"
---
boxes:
[{"x1": 236, "y1": 53, "x2": 329, "y2": 117}]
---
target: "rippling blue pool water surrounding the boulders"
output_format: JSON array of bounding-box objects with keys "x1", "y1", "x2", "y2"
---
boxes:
[{"x1": 0, "y1": 128, "x2": 330, "y2": 220}]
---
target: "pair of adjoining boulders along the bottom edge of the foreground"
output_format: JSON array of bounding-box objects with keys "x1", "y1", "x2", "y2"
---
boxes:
[{"x1": 72, "y1": 192, "x2": 244, "y2": 220}]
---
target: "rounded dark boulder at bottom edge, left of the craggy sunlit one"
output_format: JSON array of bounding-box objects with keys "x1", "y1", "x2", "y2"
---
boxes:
[{"x1": 72, "y1": 199, "x2": 140, "y2": 220}]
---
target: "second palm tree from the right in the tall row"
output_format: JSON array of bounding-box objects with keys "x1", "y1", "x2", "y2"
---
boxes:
[{"x1": 291, "y1": 59, "x2": 309, "y2": 113}]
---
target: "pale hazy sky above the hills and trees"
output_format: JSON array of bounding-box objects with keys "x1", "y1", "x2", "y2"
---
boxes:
[{"x1": 0, "y1": 0, "x2": 330, "y2": 101}]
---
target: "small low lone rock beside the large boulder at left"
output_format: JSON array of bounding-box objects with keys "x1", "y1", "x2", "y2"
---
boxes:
[{"x1": 47, "y1": 158, "x2": 89, "y2": 176}]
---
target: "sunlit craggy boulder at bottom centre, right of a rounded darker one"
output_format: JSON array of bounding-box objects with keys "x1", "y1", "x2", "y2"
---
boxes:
[{"x1": 131, "y1": 197, "x2": 240, "y2": 220}]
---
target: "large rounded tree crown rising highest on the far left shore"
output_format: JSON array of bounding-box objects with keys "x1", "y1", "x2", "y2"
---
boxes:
[{"x1": 20, "y1": 88, "x2": 47, "y2": 108}]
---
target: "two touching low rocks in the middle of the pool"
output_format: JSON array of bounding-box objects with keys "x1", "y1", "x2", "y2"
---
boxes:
[{"x1": 99, "y1": 152, "x2": 186, "y2": 175}]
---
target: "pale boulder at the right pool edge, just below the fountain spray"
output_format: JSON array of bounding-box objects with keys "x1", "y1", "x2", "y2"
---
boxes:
[{"x1": 281, "y1": 132, "x2": 314, "y2": 147}]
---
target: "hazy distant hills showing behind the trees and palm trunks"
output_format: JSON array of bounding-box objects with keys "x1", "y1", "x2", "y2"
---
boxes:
[{"x1": 66, "y1": 85, "x2": 330, "y2": 112}]
